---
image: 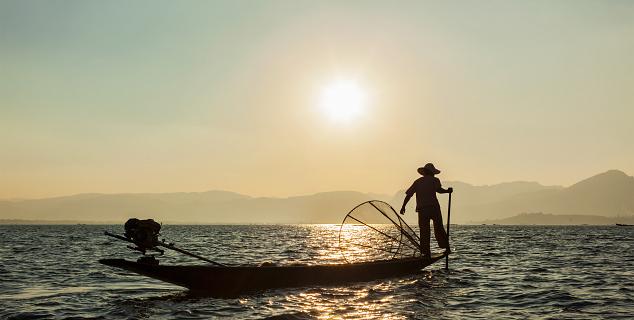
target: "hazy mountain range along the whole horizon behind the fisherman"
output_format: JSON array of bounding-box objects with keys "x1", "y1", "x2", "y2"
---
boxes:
[{"x1": 0, "y1": 170, "x2": 634, "y2": 224}]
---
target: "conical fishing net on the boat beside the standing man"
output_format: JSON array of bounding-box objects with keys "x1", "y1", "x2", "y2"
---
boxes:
[{"x1": 339, "y1": 200, "x2": 420, "y2": 263}]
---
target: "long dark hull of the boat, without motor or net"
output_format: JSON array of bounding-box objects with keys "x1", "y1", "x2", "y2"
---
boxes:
[{"x1": 99, "y1": 254, "x2": 445, "y2": 296}]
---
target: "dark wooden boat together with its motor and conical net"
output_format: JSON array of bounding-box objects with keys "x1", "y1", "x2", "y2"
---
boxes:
[{"x1": 99, "y1": 200, "x2": 447, "y2": 296}]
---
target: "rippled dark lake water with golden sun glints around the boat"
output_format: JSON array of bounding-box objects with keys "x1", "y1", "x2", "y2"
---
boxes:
[{"x1": 0, "y1": 225, "x2": 634, "y2": 319}]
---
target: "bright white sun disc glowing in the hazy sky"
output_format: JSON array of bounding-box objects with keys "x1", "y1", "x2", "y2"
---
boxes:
[{"x1": 319, "y1": 79, "x2": 367, "y2": 122}]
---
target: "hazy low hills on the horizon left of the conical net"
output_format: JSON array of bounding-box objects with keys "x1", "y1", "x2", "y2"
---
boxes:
[{"x1": 0, "y1": 191, "x2": 377, "y2": 223}]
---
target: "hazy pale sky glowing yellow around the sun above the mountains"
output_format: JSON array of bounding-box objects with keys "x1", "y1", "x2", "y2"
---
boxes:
[{"x1": 0, "y1": 0, "x2": 634, "y2": 198}]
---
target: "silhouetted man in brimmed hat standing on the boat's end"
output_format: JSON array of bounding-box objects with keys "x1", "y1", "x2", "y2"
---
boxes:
[{"x1": 401, "y1": 163, "x2": 453, "y2": 258}]
